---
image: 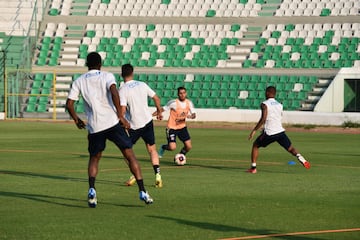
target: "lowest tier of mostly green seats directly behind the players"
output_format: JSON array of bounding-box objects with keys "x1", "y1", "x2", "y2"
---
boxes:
[{"x1": 25, "y1": 73, "x2": 318, "y2": 112}]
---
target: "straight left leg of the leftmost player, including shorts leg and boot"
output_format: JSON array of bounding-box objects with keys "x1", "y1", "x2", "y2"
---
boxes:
[{"x1": 88, "y1": 132, "x2": 106, "y2": 208}]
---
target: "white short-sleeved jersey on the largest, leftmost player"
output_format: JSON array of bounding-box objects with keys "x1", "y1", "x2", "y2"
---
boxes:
[{"x1": 68, "y1": 70, "x2": 119, "y2": 133}]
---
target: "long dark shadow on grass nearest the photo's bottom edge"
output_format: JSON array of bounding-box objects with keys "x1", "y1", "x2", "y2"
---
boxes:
[{"x1": 148, "y1": 215, "x2": 318, "y2": 240}]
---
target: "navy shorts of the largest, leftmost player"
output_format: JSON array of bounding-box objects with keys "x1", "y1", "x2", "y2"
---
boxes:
[{"x1": 88, "y1": 124, "x2": 133, "y2": 156}]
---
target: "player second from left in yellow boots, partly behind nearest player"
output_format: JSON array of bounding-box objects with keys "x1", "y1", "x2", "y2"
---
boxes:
[{"x1": 119, "y1": 64, "x2": 163, "y2": 188}]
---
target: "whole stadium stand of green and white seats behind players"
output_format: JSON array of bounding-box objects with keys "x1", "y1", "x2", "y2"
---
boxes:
[{"x1": 0, "y1": 0, "x2": 360, "y2": 116}]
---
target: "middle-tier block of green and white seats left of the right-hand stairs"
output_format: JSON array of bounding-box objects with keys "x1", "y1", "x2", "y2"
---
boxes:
[{"x1": 36, "y1": 23, "x2": 247, "y2": 67}]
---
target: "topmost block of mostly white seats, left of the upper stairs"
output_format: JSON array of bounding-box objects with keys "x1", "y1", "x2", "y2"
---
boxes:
[{"x1": 49, "y1": 0, "x2": 266, "y2": 17}]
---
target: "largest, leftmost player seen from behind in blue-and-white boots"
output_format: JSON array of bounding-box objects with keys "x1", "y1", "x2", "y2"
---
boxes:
[{"x1": 66, "y1": 52, "x2": 153, "y2": 208}]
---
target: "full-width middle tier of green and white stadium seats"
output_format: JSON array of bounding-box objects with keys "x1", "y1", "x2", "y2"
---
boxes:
[{"x1": 37, "y1": 23, "x2": 360, "y2": 68}]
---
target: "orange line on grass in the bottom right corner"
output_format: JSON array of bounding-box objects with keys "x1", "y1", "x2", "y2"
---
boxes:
[{"x1": 219, "y1": 228, "x2": 360, "y2": 240}]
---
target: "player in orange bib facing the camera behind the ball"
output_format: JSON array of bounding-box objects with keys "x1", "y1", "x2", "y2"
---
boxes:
[{"x1": 153, "y1": 87, "x2": 196, "y2": 158}]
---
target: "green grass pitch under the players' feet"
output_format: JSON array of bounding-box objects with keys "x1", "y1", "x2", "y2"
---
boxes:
[{"x1": 0, "y1": 121, "x2": 360, "y2": 240}]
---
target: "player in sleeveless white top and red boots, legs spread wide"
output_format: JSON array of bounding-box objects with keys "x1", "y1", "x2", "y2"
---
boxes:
[{"x1": 247, "y1": 86, "x2": 310, "y2": 173}]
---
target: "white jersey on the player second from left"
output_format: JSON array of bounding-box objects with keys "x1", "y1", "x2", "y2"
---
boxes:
[{"x1": 119, "y1": 80, "x2": 156, "y2": 130}]
